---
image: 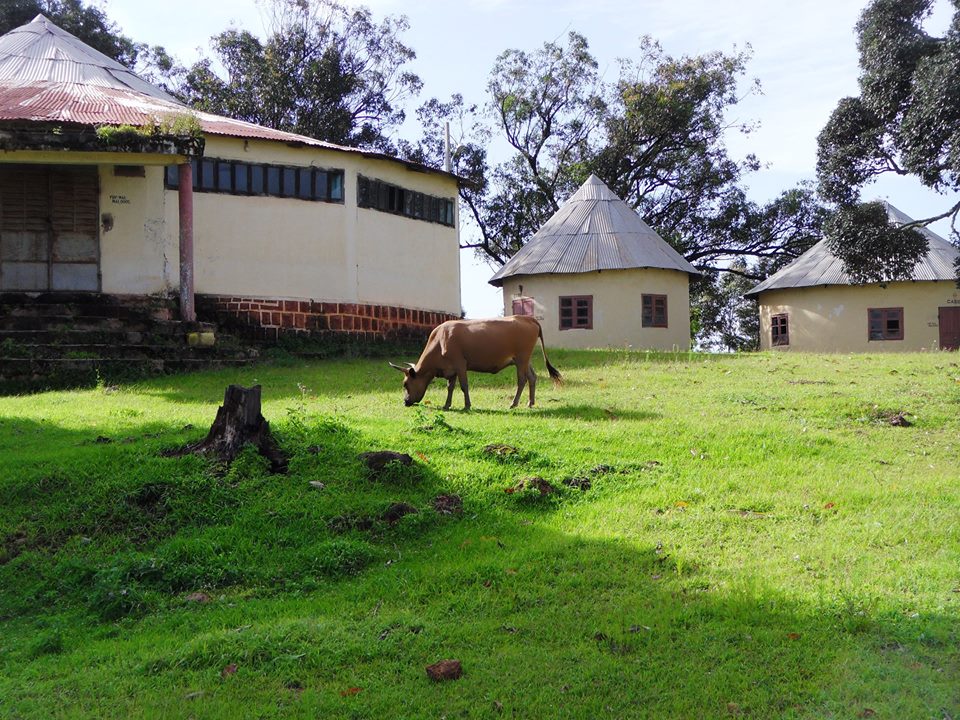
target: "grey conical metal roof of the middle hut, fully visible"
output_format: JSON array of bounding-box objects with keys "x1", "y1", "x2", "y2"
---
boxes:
[{"x1": 490, "y1": 175, "x2": 699, "y2": 286}]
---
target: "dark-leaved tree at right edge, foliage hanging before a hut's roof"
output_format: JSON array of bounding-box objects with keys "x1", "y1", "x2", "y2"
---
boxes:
[{"x1": 817, "y1": 0, "x2": 960, "y2": 282}]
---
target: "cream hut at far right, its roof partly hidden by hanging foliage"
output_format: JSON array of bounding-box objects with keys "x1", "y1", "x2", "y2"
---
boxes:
[{"x1": 746, "y1": 203, "x2": 960, "y2": 352}]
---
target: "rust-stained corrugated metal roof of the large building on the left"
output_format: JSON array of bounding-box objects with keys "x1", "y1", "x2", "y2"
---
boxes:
[{"x1": 0, "y1": 15, "x2": 458, "y2": 179}]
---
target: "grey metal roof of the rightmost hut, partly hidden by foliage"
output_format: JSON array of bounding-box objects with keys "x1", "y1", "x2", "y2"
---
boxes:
[{"x1": 745, "y1": 202, "x2": 960, "y2": 297}]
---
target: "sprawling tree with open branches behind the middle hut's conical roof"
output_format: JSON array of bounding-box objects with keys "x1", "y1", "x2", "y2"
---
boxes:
[{"x1": 404, "y1": 32, "x2": 822, "y2": 278}]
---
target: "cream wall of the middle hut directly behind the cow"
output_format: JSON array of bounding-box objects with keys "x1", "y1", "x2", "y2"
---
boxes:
[{"x1": 503, "y1": 269, "x2": 690, "y2": 350}]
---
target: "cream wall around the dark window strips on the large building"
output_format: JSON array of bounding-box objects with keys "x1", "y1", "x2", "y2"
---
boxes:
[{"x1": 165, "y1": 137, "x2": 460, "y2": 315}]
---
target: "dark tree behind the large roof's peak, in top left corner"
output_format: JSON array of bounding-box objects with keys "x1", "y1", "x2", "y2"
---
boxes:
[{"x1": 0, "y1": 0, "x2": 145, "y2": 68}]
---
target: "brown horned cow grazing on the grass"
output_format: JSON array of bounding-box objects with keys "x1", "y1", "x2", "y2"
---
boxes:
[{"x1": 390, "y1": 315, "x2": 563, "y2": 410}]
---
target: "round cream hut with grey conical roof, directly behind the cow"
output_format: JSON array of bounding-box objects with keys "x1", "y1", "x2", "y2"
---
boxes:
[{"x1": 490, "y1": 175, "x2": 699, "y2": 350}]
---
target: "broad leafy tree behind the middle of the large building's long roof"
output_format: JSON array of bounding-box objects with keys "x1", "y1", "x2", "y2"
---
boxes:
[{"x1": 171, "y1": 0, "x2": 421, "y2": 152}]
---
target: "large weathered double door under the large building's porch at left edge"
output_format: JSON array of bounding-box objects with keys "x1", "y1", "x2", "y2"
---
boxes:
[{"x1": 0, "y1": 165, "x2": 100, "y2": 292}]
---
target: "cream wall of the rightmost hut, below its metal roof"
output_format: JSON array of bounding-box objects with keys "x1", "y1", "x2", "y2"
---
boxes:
[{"x1": 758, "y1": 280, "x2": 960, "y2": 352}]
